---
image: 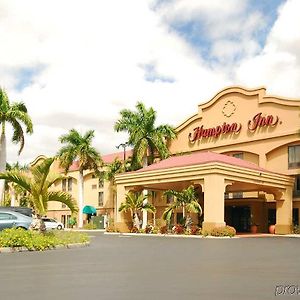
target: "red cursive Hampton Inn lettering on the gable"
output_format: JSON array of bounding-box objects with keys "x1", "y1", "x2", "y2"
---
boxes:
[{"x1": 188, "y1": 112, "x2": 279, "y2": 143}]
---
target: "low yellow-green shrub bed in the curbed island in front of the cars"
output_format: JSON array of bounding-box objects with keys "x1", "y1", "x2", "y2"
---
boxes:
[{"x1": 0, "y1": 228, "x2": 89, "y2": 251}]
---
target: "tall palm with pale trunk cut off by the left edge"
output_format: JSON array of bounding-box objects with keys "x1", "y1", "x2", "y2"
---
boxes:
[{"x1": 0, "y1": 88, "x2": 33, "y2": 202}]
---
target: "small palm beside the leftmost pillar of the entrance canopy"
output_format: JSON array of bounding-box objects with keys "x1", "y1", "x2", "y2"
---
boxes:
[{"x1": 119, "y1": 192, "x2": 156, "y2": 228}]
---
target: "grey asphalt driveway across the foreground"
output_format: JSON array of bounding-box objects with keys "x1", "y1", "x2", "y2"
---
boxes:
[{"x1": 0, "y1": 232, "x2": 300, "y2": 300}]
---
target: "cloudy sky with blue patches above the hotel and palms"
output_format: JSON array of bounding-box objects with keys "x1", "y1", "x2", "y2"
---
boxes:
[{"x1": 0, "y1": 0, "x2": 300, "y2": 163}]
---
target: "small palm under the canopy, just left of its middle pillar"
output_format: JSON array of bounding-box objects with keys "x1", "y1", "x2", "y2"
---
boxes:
[{"x1": 163, "y1": 185, "x2": 202, "y2": 226}]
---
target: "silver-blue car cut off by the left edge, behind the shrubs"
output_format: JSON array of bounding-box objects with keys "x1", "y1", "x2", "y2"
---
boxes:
[{"x1": 0, "y1": 210, "x2": 32, "y2": 230}]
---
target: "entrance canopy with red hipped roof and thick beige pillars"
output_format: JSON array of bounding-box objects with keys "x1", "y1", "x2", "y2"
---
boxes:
[{"x1": 116, "y1": 152, "x2": 293, "y2": 234}]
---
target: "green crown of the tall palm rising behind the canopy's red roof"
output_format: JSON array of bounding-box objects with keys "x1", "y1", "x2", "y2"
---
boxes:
[{"x1": 114, "y1": 102, "x2": 176, "y2": 169}]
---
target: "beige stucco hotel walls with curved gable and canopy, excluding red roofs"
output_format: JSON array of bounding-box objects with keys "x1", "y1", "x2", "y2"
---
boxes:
[{"x1": 27, "y1": 87, "x2": 300, "y2": 234}]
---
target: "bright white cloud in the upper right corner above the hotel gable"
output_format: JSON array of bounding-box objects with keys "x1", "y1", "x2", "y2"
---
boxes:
[{"x1": 236, "y1": 0, "x2": 300, "y2": 98}]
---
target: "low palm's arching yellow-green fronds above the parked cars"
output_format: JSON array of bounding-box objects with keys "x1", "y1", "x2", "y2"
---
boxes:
[{"x1": 0, "y1": 158, "x2": 78, "y2": 217}]
